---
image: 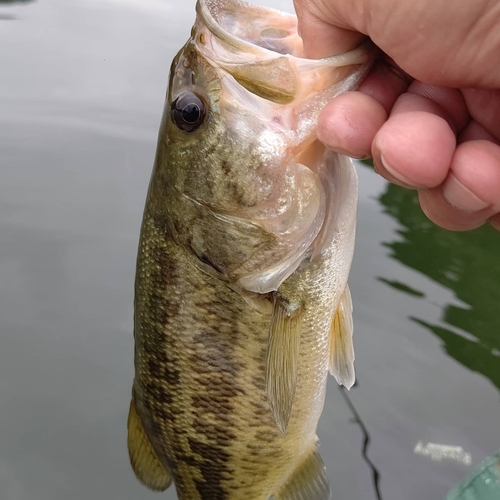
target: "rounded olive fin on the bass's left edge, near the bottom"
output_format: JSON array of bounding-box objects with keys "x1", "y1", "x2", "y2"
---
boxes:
[{"x1": 127, "y1": 400, "x2": 172, "y2": 491}]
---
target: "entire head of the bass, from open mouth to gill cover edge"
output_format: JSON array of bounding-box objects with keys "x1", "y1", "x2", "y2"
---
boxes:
[{"x1": 155, "y1": 0, "x2": 372, "y2": 293}]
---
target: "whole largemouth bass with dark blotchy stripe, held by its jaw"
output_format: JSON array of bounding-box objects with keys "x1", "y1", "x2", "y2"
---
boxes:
[{"x1": 128, "y1": 0, "x2": 373, "y2": 500}]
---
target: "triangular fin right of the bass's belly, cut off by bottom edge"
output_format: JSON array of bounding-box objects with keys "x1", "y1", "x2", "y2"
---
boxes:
[{"x1": 271, "y1": 444, "x2": 331, "y2": 500}]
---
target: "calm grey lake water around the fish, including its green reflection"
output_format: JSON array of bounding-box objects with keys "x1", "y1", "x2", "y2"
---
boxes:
[{"x1": 0, "y1": 0, "x2": 500, "y2": 500}]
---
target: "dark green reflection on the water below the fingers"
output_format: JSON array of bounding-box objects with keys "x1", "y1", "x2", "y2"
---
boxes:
[{"x1": 379, "y1": 170, "x2": 500, "y2": 389}]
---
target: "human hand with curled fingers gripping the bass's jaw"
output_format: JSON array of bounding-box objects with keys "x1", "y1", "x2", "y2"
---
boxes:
[{"x1": 294, "y1": 0, "x2": 500, "y2": 230}]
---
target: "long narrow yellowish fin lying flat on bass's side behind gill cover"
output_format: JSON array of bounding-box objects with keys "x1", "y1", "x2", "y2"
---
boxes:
[{"x1": 266, "y1": 292, "x2": 302, "y2": 433}]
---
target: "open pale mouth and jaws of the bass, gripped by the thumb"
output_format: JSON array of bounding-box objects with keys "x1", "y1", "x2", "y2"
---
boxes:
[{"x1": 192, "y1": 0, "x2": 374, "y2": 104}]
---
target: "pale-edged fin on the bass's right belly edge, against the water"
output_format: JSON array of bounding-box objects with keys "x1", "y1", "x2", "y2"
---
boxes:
[{"x1": 330, "y1": 286, "x2": 356, "y2": 389}]
